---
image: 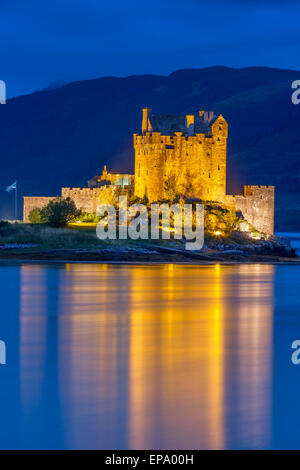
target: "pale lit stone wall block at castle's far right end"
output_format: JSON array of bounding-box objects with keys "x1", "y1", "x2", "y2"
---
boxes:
[{"x1": 224, "y1": 186, "x2": 275, "y2": 235}]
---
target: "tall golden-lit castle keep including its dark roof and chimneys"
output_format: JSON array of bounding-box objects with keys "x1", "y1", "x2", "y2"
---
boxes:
[{"x1": 134, "y1": 108, "x2": 228, "y2": 202}]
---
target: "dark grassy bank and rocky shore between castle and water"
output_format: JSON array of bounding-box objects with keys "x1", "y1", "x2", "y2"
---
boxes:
[{"x1": 0, "y1": 224, "x2": 300, "y2": 265}]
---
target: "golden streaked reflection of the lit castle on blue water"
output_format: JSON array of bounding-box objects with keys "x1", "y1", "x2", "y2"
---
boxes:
[{"x1": 20, "y1": 264, "x2": 274, "y2": 449}]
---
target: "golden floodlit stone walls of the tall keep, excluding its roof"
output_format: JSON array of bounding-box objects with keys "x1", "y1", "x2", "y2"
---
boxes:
[{"x1": 134, "y1": 116, "x2": 228, "y2": 202}]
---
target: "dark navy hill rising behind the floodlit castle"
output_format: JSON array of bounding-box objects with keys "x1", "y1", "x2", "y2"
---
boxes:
[{"x1": 0, "y1": 67, "x2": 300, "y2": 231}]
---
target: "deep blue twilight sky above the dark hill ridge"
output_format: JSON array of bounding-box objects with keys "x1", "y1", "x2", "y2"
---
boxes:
[{"x1": 0, "y1": 0, "x2": 300, "y2": 97}]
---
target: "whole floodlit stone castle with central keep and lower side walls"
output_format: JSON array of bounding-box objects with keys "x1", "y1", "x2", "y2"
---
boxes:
[{"x1": 24, "y1": 108, "x2": 275, "y2": 235}]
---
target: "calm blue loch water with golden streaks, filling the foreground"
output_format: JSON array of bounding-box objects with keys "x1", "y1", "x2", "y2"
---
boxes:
[{"x1": 0, "y1": 264, "x2": 300, "y2": 449}]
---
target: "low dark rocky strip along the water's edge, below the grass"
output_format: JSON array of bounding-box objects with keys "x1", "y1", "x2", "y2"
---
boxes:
[{"x1": 0, "y1": 237, "x2": 300, "y2": 265}]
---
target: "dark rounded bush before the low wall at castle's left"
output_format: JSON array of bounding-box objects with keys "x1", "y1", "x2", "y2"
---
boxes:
[{"x1": 41, "y1": 197, "x2": 80, "y2": 227}]
